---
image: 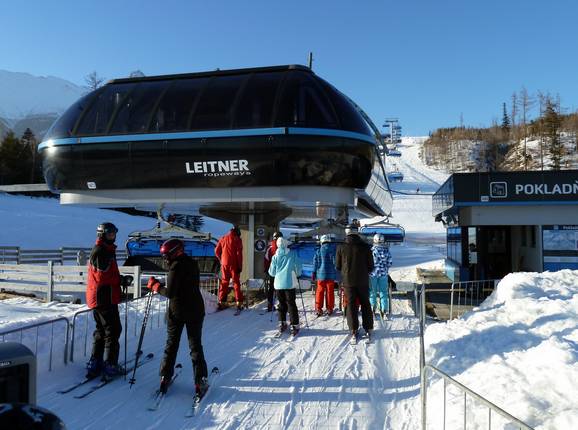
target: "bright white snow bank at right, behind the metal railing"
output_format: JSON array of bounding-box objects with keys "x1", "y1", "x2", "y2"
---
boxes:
[{"x1": 425, "y1": 270, "x2": 578, "y2": 429}]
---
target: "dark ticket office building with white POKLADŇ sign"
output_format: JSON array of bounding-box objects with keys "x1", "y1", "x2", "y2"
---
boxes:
[{"x1": 433, "y1": 170, "x2": 578, "y2": 281}]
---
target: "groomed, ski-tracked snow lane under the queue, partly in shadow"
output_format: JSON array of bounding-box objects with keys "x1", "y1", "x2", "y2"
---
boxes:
[{"x1": 39, "y1": 292, "x2": 419, "y2": 430}]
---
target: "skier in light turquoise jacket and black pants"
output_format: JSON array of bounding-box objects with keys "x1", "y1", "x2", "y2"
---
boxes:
[{"x1": 269, "y1": 237, "x2": 301, "y2": 336}]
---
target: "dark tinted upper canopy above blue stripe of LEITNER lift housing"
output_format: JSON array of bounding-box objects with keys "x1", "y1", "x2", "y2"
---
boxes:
[{"x1": 45, "y1": 66, "x2": 373, "y2": 139}]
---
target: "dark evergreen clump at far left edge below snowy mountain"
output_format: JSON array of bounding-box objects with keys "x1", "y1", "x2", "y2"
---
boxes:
[{"x1": 0, "y1": 131, "x2": 31, "y2": 185}]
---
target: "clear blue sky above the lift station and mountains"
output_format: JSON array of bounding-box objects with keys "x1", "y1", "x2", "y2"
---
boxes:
[{"x1": 0, "y1": 0, "x2": 578, "y2": 136}]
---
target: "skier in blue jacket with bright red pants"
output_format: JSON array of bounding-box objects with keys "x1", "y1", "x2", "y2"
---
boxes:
[{"x1": 311, "y1": 234, "x2": 337, "y2": 316}]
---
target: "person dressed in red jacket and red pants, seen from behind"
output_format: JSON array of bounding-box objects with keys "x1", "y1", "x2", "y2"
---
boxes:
[{"x1": 215, "y1": 226, "x2": 243, "y2": 310}]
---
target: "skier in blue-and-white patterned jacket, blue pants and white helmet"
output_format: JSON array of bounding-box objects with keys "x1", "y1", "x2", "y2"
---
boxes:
[{"x1": 369, "y1": 233, "x2": 392, "y2": 319}]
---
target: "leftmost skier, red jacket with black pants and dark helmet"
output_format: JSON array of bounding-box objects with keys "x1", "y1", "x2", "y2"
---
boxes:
[{"x1": 86, "y1": 222, "x2": 128, "y2": 378}]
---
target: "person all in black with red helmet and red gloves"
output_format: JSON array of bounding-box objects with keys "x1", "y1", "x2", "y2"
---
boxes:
[{"x1": 147, "y1": 239, "x2": 208, "y2": 396}]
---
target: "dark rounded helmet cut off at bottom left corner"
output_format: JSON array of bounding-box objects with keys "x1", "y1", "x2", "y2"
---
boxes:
[{"x1": 0, "y1": 403, "x2": 66, "y2": 430}]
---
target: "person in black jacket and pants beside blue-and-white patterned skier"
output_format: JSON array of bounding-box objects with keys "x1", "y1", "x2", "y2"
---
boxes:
[{"x1": 335, "y1": 226, "x2": 373, "y2": 337}]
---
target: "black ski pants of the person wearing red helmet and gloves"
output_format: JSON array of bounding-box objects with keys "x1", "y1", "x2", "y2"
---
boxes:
[{"x1": 160, "y1": 310, "x2": 208, "y2": 384}]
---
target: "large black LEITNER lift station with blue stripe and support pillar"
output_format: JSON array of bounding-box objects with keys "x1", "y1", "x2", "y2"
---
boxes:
[{"x1": 39, "y1": 65, "x2": 392, "y2": 279}]
